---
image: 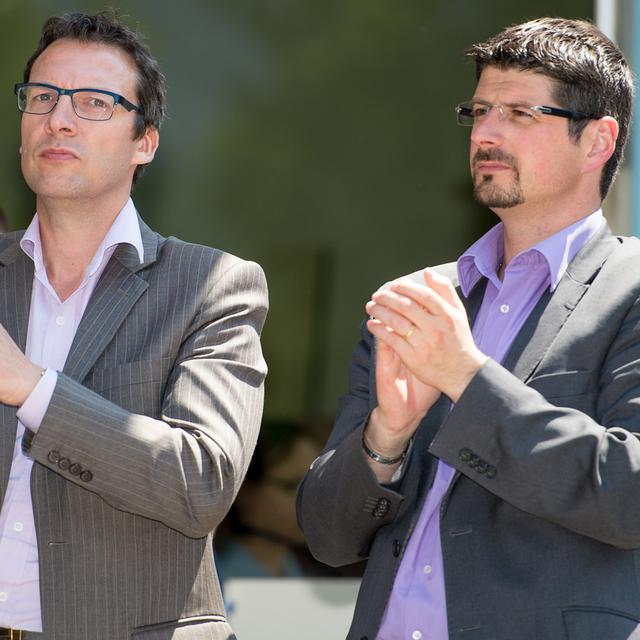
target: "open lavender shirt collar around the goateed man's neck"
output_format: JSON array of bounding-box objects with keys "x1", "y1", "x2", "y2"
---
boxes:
[{"x1": 457, "y1": 209, "x2": 604, "y2": 297}]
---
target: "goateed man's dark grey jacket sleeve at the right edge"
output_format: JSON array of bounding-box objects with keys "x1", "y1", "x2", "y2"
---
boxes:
[{"x1": 430, "y1": 288, "x2": 640, "y2": 548}]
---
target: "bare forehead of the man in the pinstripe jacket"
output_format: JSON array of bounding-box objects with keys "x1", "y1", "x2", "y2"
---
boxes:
[{"x1": 29, "y1": 38, "x2": 137, "y2": 95}]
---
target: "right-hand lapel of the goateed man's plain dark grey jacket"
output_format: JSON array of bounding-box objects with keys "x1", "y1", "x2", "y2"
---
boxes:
[{"x1": 503, "y1": 225, "x2": 620, "y2": 381}]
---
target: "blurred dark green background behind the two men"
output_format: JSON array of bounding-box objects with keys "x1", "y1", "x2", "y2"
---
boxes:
[{"x1": 0, "y1": 0, "x2": 640, "y2": 638}]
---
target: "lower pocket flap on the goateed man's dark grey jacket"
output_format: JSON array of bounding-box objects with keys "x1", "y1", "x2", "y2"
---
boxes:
[{"x1": 562, "y1": 607, "x2": 640, "y2": 640}]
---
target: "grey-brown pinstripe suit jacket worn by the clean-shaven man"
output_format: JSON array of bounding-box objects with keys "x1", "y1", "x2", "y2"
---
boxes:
[{"x1": 0, "y1": 221, "x2": 267, "y2": 640}]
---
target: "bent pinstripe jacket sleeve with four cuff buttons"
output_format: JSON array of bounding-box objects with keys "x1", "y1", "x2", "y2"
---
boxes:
[{"x1": 24, "y1": 261, "x2": 268, "y2": 537}]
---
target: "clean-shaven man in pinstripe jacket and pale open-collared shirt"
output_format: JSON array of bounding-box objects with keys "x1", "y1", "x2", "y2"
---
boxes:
[{"x1": 0, "y1": 14, "x2": 267, "y2": 640}]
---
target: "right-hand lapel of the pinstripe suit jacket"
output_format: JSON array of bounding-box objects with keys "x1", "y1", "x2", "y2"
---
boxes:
[{"x1": 63, "y1": 220, "x2": 158, "y2": 382}]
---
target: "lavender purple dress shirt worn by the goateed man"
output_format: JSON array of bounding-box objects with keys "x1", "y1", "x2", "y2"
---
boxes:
[{"x1": 377, "y1": 209, "x2": 603, "y2": 640}]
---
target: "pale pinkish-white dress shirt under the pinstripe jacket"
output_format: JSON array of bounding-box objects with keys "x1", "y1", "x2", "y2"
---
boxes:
[{"x1": 0, "y1": 200, "x2": 144, "y2": 631}]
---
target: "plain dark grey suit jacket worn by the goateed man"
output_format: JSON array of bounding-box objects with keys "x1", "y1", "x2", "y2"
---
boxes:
[{"x1": 298, "y1": 229, "x2": 640, "y2": 640}]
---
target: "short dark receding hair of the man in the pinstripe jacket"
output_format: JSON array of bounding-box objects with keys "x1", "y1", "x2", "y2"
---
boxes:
[{"x1": 24, "y1": 11, "x2": 167, "y2": 184}]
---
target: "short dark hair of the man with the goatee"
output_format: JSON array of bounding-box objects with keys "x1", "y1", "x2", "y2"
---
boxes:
[{"x1": 466, "y1": 18, "x2": 634, "y2": 199}]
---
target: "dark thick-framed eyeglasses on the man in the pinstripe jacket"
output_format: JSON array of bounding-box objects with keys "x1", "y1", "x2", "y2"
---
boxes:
[{"x1": 13, "y1": 82, "x2": 142, "y2": 120}]
